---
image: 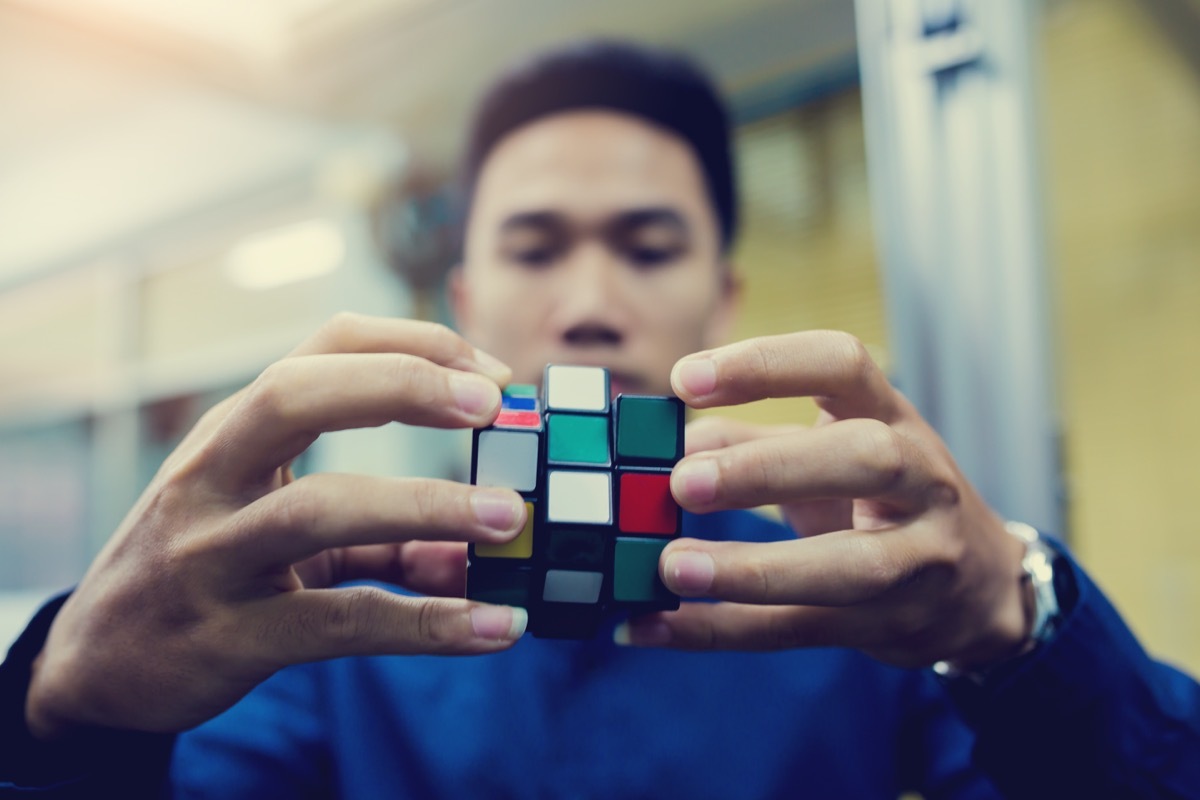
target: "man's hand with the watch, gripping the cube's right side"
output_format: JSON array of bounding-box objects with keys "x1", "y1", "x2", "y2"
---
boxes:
[{"x1": 629, "y1": 331, "x2": 1031, "y2": 667}]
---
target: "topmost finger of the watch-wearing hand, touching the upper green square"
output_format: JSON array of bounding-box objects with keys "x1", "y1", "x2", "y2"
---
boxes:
[{"x1": 671, "y1": 331, "x2": 895, "y2": 420}]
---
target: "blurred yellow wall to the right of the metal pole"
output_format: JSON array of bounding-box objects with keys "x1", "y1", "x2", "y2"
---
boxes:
[{"x1": 1042, "y1": 0, "x2": 1200, "y2": 672}]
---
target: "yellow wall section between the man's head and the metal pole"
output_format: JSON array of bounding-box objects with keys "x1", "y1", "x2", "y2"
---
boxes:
[{"x1": 719, "y1": 91, "x2": 887, "y2": 423}]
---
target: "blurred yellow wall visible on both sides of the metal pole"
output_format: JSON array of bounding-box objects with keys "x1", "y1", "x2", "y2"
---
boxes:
[{"x1": 720, "y1": 0, "x2": 1200, "y2": 672}]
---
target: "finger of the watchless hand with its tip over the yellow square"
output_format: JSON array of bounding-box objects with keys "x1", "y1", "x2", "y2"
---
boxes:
[{"x1": 228, "y1": 474, "x2": 526, "y2": 571}]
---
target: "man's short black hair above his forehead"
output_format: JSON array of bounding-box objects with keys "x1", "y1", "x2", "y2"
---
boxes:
[{"x1": 461, "y1": 40, "x2": 738, "y2": 252}]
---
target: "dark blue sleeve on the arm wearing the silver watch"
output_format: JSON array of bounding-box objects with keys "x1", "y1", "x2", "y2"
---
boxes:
[{"x1": 950, "y1": 546, "x2": 1200, "y2": 799}]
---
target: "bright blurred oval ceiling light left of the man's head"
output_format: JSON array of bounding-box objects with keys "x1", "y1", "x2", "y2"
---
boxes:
[{"x1": 226, "y1": 219, "x2": 346, "y2": 289}]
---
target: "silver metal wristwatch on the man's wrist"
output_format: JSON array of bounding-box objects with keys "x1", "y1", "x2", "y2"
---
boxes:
[{"x1": 934, "y1": 522, "x2": 1075, "y2": 686}]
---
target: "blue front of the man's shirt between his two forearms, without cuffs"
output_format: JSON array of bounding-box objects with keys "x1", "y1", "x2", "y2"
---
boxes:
[{"x1": 172, "y1": 512, "x2": 1200, "y2": 800}]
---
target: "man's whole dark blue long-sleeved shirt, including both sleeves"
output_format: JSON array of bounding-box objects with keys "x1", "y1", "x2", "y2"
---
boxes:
[{"x1": 0, "y1": 512, "x2": 1200, "y2": 800}]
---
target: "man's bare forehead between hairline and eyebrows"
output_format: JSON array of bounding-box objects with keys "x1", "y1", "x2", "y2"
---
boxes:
[{"x1": 472, "y1": 110, "x2": 716, "y2": 230}]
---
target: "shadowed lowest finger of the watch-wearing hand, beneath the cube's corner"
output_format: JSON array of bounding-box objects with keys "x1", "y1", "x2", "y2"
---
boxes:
[{"x1": 613, "y1": 603, "x2": 862, "y2": 650}]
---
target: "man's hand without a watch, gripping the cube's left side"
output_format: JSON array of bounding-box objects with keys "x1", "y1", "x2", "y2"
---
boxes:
[{"x1": 25, "y1": 315, "x2": 524, "y2": 740}]
